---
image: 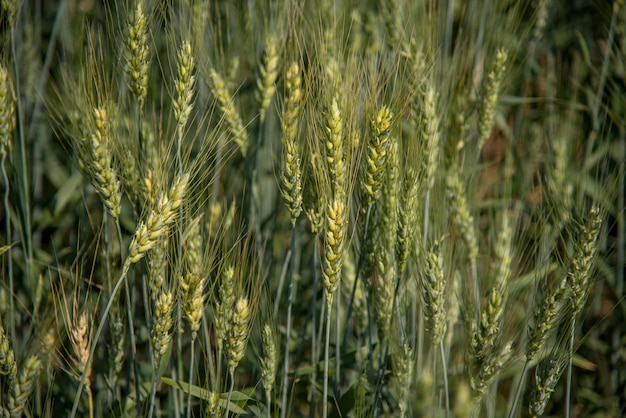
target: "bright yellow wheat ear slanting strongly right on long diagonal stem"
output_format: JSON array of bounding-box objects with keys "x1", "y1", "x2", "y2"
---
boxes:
[{"x1": 124, "y1": 173, "x2": 189, "y2": 268}]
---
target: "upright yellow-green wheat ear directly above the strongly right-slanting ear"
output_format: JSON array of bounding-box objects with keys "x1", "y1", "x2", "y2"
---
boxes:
[{"x1": 173, "y1": 40, "x2": 196, "y2": 137}]
